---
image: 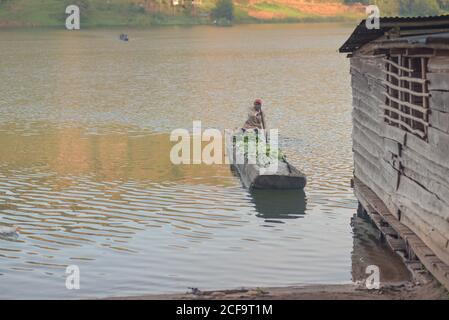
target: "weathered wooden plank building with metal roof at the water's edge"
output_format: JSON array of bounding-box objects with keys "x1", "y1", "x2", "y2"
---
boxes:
[{"x1": 340, "y1": 16, "x2": 449, "y2": 289}]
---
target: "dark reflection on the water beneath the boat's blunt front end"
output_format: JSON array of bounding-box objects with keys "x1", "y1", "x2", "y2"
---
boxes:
[{"x1": 251, "y1": 190, "x2": 307, "y2": 222}]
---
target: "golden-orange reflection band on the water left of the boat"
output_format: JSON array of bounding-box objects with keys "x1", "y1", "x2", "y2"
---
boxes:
[{"x1": 0, "y1": 125, "x2": 230, "y2": 185}]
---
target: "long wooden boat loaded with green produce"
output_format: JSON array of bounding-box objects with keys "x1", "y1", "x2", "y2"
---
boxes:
[{"x1": 226, "y1": 130, "x2": 307, "y2": 190}]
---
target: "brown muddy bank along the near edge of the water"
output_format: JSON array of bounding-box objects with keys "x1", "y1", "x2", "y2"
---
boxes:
[{"x1": 107, "y1": 280, "x2": 449, "y2": 300}]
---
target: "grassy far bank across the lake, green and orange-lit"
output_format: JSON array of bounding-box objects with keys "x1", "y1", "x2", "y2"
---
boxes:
[{"x1": 0, "y1": 0, "x2": 449, "y2": 27}]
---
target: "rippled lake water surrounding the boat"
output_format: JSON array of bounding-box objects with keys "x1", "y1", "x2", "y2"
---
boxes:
[{"x1": 0, "y1": 24, "x2": 406, "y2": 298}]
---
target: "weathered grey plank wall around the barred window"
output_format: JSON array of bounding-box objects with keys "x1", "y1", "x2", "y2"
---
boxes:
[{"x1": 351, "y1": 54, "x2": 449, "y2": 265}]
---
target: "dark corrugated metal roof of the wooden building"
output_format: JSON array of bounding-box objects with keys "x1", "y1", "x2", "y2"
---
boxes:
[{"x1": 339, "y1": 15, "x2": 449, "y2": 53}]
